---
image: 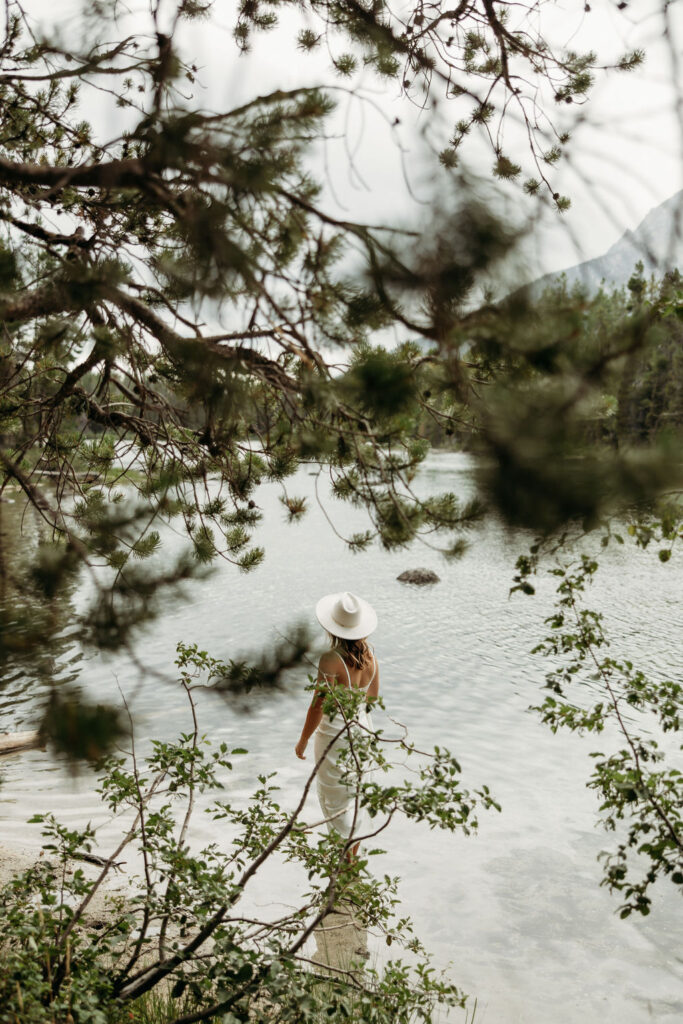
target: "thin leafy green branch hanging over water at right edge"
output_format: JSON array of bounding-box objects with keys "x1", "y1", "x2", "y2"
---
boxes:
[{"x1": 514, "y1": 555, "x2": 683, "y2": 918}]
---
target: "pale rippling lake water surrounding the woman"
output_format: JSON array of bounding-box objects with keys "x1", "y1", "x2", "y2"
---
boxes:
[{"x1": 0, "y1": 454, "x2": 683, "y2": 1024}]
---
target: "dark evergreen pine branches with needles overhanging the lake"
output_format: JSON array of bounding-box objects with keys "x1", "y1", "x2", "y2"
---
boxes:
[{"x1": 0, "y1": 0, "x2": 670, "y2": 753}]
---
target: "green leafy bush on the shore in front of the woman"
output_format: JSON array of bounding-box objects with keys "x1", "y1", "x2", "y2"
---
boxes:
[{"x1": 0, "y1": 644, "x2": 497, "y2": 1024}]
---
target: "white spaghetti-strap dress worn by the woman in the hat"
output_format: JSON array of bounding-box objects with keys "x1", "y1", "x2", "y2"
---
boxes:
[{"x1": 314, "y1": 652, "x2": 377, "y2": 839}]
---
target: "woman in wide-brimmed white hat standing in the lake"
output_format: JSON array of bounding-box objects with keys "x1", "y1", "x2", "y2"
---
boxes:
[{"x1": 295, "y1": 591, "x2": 380, "y2": 856}]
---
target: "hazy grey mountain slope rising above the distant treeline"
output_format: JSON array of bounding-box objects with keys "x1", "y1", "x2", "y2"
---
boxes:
[{"x1": 529, "y1": 189, "x2": 683, "y2": 295}]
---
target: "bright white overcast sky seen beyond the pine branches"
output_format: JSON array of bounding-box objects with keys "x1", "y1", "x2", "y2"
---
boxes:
[{"x1": 17, "y1": 0, "x2": 683, "y2": 275}]
